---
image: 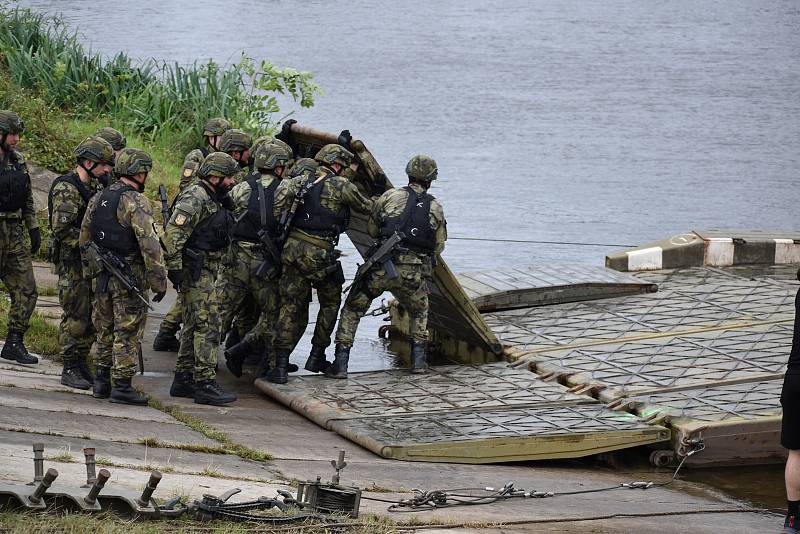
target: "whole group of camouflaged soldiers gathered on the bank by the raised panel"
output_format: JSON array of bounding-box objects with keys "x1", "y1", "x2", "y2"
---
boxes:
[{"x1": 0, "y1": 111, "x2": 447, "y2": 405}]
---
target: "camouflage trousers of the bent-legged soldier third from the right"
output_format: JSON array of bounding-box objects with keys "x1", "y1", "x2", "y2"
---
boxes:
[{"x1": 216, "y1": 243, "x2": 278, "y2": 347}]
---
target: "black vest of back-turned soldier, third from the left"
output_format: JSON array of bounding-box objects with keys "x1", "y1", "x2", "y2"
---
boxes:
[{"x1": 89, "y1": 182, "x2": 139, "y2": 256}]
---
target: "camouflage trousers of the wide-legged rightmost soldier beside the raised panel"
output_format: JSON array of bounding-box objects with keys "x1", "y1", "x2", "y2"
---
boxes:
[{"x1": 336, "y1": 263, "x2": 428, "y2": 347}]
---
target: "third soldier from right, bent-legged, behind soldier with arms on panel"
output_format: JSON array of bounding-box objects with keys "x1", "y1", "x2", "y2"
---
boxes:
[{"x1": 217, "y1": 144, "x2": 297, "y2": 377}]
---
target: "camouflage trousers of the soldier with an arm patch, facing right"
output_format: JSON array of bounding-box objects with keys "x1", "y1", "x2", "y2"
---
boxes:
[{"x1": 175, "y1": 254, "x2": 220, "y2": 381}]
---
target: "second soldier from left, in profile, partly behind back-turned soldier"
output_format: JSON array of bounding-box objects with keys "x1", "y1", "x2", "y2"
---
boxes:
[{"x1": 47, "y1": 137, "x2": 114, "y2": 389}]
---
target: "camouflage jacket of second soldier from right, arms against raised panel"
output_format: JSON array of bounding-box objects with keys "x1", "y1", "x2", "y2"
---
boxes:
[{"x1": 275, "y1": 166, "x2": 372, "y2": 240}]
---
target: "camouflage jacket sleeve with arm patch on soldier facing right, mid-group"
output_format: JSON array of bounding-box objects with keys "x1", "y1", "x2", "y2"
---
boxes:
[{"x1": 164, "y1": 180, "x2": 222, "y2": 271}]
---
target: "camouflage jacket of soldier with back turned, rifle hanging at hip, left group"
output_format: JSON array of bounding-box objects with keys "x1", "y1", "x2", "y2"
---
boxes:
[{"x1": 80, "y1": 182, "x2": 167, "y2": 293}]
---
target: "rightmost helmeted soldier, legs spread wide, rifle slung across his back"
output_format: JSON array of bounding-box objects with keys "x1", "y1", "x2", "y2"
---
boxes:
[{"x1": 325, "y1": 155, "x2": 447, "y2": 378}]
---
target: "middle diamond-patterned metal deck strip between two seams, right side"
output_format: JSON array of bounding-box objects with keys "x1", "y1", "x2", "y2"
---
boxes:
[{"x1": 533, "y1": 323, "x2": 792, "y2": 391}]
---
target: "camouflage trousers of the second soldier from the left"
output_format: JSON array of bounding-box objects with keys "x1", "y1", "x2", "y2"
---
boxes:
[{"x1": 56, "y1": 253, "x2": 95, "y2": 361}]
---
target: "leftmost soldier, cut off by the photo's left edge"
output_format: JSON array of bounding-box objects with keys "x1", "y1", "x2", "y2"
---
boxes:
[{"x1": 0, "y1": 110, "x2": 42, "y2": 365}]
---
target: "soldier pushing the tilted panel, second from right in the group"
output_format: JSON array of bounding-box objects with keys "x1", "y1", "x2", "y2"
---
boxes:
[{"x1": 268, "y1": 144, "x2": 372, "y2": 384}]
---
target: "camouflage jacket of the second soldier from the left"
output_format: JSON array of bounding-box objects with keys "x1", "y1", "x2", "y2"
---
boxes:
[{"x1": 50, "y1": 171, "x2": 102, "y2": 261}]
